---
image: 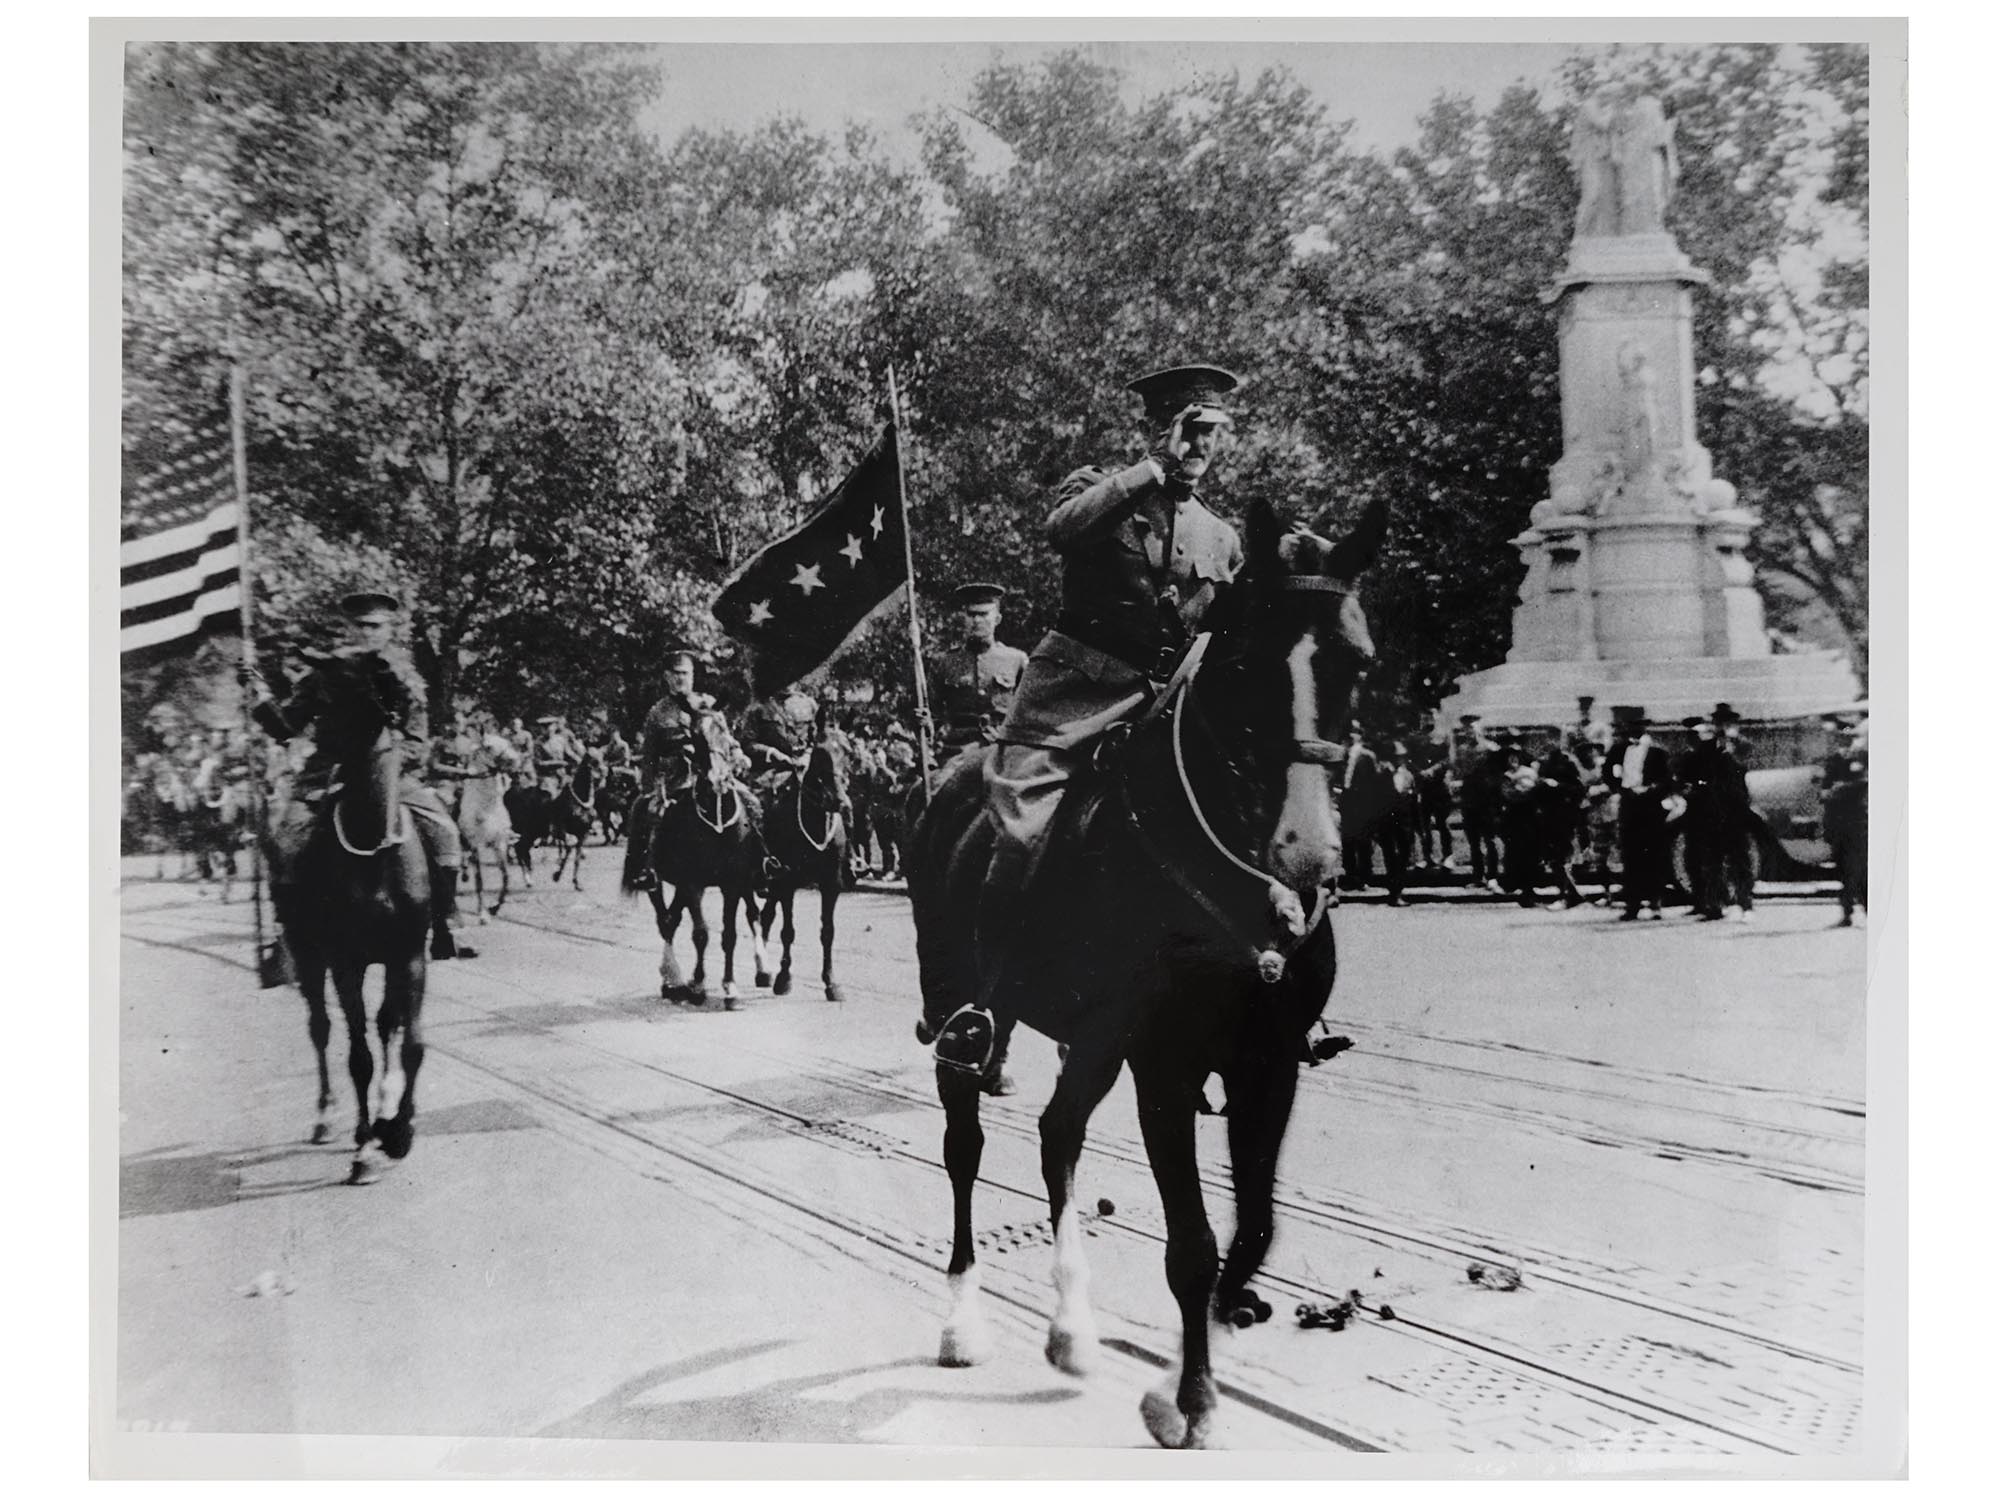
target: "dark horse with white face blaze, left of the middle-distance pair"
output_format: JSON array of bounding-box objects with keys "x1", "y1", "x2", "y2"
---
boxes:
[{"x1": 624, "y1": 718, "x2": 770, "y2": 1010}]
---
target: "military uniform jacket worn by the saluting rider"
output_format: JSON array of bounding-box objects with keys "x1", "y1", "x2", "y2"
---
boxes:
[{"x1": 998, "y1": 460, "x2": 1242, "y2": 750}]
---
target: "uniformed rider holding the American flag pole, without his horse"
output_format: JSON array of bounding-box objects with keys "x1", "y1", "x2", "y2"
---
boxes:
[{"x1": 246, "y1": 592, "x2": 474, "y2": 958}]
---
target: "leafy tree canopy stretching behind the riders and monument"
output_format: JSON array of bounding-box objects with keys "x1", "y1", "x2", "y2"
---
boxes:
[{"x1": 124, "y1": 42, "x2": 1868, "y2": 722}]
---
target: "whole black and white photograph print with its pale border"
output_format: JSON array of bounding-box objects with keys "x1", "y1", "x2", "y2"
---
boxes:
[{"x1": 90, "y1": 20, "x2": 1908, "y2": 1478}]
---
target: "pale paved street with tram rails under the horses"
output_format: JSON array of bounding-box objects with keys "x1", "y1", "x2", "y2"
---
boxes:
[{"x1": 118, "y1": 848, "x2": 1866, "y2": 1454}]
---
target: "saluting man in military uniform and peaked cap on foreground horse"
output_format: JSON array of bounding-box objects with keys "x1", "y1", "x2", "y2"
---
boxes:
[{"x1": 924, "y1": 364, "x2": 1242, "y2": 1086}]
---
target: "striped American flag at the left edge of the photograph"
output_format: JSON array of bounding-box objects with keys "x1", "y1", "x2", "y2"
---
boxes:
[{"x1": 118, "y1": 416, "x2": 242, "y2": 654}]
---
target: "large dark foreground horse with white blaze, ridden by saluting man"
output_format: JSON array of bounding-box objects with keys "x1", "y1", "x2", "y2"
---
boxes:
[{"x1": 910, "y1": 504, "x2": 1386, "y2": 1448}]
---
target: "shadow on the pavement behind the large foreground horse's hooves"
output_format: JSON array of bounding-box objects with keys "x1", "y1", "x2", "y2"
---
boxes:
[{"x1": 536, "y1": 1340, "x2": 1084, "y2": 1442}]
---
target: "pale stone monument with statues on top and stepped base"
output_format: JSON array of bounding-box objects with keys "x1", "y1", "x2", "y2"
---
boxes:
[{"x1": 1440, "y1": 94, "x2": 1860, "y2": 728}]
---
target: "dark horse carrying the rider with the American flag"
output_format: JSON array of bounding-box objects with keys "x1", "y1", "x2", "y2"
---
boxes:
[{"x1": 272, "y1": 664, "x2": 430, "y2": 1182}]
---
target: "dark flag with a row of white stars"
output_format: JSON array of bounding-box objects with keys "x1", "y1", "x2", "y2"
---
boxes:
[{"x1": 710, "y1": 426, "x2": 910, "y2": 694}]
